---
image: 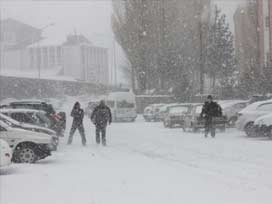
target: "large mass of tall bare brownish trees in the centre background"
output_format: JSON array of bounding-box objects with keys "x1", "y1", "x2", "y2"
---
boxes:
[{"x1": 112, "y1": 0, "x2": 209, "y2": 94}]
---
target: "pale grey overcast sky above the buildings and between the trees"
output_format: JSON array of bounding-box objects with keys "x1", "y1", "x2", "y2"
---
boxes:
[{"x1": 0, "y1": 0, "x2": 249, "y2": 83}]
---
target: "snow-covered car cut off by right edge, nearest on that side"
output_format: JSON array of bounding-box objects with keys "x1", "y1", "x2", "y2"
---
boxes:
[{"x1": 254, "y1": 112, "x2": 272, "y2": 138}]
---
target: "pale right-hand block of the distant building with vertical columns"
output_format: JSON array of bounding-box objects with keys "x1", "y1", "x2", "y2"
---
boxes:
[{"x1": 62, "y1": 35, "x2": 109, "y2": 85}]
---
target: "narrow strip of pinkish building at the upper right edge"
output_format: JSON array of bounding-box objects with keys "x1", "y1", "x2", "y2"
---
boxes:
[{"x1": 257, "y1": 0, "x2": 272, "y2": 67}]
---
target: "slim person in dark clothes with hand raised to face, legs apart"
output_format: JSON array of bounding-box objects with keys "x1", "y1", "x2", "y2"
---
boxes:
[{"x1": 68, "y1": 102, "x2": 86, "y2": 146}]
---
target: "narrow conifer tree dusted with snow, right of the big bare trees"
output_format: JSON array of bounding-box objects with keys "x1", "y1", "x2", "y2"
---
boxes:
[{"x1": 205, "y1": 7, "x2": 238, "y2": 97}]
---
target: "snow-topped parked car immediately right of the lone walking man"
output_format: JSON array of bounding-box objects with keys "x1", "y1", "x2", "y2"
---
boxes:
[{"x1": 221, "y1": 100, "x2": 248, "y2": 127}]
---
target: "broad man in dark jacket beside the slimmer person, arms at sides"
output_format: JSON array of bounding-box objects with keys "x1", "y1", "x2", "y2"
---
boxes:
[{"x1": 91, "y1": 100, "x2": 112, "y2": 146}]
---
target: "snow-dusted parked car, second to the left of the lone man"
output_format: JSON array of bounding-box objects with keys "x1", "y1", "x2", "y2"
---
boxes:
[{"x1": 163, "y1": 104, "x2": 191, "y2": 128}]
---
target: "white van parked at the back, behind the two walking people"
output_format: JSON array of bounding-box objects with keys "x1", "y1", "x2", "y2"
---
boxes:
[{"x1": 106, "y1": 92, "x2": 137, "y2": 122}]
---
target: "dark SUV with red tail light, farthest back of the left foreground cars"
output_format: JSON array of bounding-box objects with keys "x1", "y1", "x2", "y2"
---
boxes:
[{"x1": 1, "y1": 100, "x2": 66, "y2": 135}]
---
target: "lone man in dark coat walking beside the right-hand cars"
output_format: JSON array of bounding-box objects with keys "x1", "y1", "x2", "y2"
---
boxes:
[{"x1": 200, "y1": 95, "x2": 222, "y2": 137}]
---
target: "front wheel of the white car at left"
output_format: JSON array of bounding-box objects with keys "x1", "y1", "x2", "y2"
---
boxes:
[{"x1": 13, "y1": 143, "x2": 38, "y2": 163}]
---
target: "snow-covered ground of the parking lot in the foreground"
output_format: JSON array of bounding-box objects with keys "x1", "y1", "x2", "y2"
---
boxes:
[{"x1": 0, "y1": 119, "x2": 272, "y2": 204}]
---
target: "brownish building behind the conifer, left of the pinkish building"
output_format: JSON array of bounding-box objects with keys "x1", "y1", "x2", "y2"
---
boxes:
[{"x1": 234, "y1": 3, "x2": 258, "y2": 78}]
